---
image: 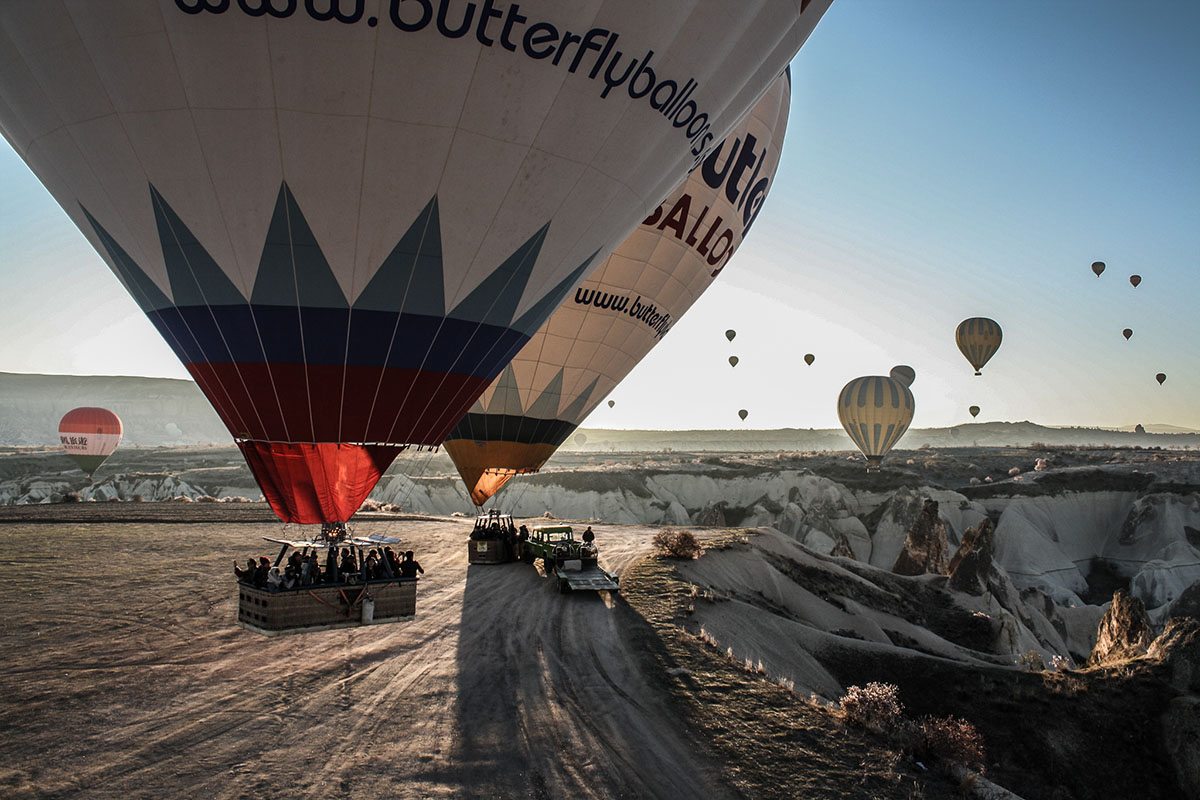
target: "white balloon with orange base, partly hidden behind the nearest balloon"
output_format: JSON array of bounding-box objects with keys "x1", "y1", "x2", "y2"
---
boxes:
[{"x1": 445, "y1": 74, "x2": 791, "y2": 505}]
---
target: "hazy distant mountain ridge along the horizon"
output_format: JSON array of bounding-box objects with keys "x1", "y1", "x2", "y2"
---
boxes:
[{"x1": 0, "y1": 372, "x2": 1200, "y2": 451}]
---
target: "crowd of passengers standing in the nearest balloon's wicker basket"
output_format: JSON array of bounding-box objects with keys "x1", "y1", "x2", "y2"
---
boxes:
[{"x1": 233, "y1": 547, "x2": 425, "y2": 591}]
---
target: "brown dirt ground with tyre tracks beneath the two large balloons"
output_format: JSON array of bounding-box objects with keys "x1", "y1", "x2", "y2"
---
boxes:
[{"x1": 0, "y1": 507, "x2": 724, "y2": 800}]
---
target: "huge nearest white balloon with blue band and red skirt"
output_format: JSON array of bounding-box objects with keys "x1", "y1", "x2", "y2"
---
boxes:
[{"x1": 0, "y1": 0, "x2": 829, "y2": 523}]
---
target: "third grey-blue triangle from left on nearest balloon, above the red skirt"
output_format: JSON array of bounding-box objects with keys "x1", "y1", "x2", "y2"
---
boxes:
[{"x1": 251, "y1": 181, "x2": 349, "y2": 308}]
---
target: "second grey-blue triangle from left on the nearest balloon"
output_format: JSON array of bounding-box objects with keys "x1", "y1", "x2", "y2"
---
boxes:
[{"x1": 150, "y1": 184, "x2": 246, "y2": 306}]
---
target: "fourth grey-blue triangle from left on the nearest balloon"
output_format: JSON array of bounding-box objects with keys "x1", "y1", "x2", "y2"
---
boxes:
[{"x1": 354, "y1": 194, "x2": 446, "y2": 317}]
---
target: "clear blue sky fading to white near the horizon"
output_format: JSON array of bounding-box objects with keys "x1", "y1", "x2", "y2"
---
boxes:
[{"x1": 0, "y1": 0, "x2": 1200, "y2": 429}]
